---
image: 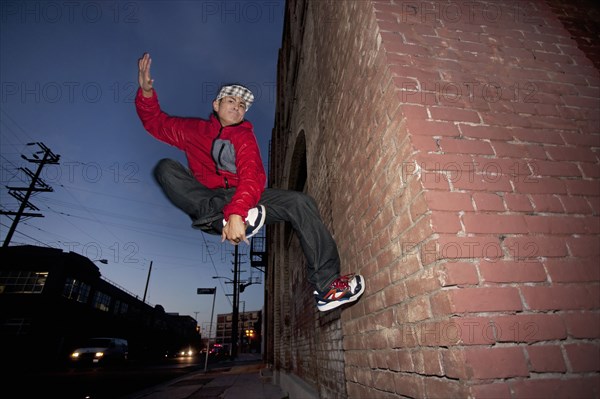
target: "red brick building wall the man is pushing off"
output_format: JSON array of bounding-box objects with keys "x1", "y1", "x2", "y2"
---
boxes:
[{"x1": 266, "y1": 0, "x2": 600, "y2": 398}]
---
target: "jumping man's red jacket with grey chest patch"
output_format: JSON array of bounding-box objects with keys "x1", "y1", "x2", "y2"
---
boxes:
[{"x1": 135, "y1": 89, "x2": 266, "y2": 220}]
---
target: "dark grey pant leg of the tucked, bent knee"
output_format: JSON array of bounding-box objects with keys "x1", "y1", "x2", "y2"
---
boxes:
[{"x1": 154, "y1": 159, "x2": 235, "y2": 234}]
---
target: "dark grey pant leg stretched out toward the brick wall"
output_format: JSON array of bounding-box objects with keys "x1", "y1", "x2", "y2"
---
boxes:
[{"x1": 259, "y1": 188, "x2": 340, "y2": 291}]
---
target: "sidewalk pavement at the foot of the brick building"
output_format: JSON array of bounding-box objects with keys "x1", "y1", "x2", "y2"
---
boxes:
[{"x1": 125, "y1": 353, "x2": 288, "y2": 399}]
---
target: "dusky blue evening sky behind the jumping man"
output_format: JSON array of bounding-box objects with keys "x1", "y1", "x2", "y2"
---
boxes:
[{"x1": 0, "y1": 0, "x2": 284, "y2": 332}]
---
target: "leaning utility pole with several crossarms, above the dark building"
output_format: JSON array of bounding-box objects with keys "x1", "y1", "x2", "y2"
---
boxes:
[{"x1": 0, "y1": 143, "x2": 60, "y2": 247}]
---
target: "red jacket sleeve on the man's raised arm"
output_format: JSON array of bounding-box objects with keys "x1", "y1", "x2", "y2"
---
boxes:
[{"x1": 135, "y1": 89, "x2": 194, "y2": 150}]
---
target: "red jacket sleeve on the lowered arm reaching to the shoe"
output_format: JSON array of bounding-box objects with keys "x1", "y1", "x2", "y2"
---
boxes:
[{"x1": 223, "y1": 130, "x2": 267, "y2": 220}]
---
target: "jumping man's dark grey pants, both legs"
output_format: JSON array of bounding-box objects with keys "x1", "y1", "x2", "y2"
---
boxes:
[{"x1": 154, "y1": 159, "x2": 340, "y2": 291}]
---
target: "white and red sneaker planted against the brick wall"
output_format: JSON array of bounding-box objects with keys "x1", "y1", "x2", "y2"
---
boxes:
[{"x1": 314, "y1": 274, "x2": 365, "y2": 312}]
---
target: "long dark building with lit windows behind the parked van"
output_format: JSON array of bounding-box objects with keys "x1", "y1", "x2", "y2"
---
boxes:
[{"x1": 0, "y1": 245, "x2": 201, "y2": 370}]
